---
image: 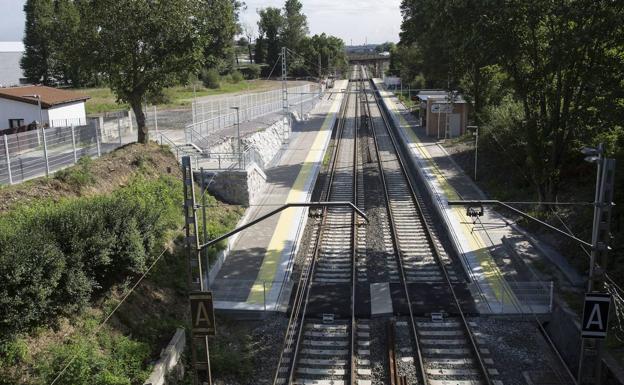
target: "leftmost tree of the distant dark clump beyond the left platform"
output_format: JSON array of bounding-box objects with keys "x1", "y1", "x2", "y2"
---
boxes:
[{"x1": 256, "y1": 7, "x2": 284, "y2": 66}]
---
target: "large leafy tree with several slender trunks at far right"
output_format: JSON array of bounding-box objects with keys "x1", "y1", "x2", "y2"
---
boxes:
[{"x1": 491, "y1": 0, "x2": 624, "y2": 201}]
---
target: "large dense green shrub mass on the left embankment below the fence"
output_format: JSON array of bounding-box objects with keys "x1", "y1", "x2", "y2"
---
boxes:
[{"x1": 0, "y1": 178, "x2": 182, "y2": 343}]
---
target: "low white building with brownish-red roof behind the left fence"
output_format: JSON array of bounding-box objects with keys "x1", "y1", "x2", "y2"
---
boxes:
[{"x1": 0, "y1": 86, "x2": 89, "y2": 130}]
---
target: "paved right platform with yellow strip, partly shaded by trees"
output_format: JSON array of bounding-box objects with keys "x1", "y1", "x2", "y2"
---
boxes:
[{"x1": 374, "y1": 79, "x2": 552, "y2": 314}]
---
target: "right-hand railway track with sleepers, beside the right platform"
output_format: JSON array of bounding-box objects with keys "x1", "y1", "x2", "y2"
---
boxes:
[{"x1": 366, "y1": 76, "x2": 501, "y2": 385}]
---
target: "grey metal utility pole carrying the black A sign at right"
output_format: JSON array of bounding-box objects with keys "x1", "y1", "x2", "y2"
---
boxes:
[{"x1": 577, "y1": 143, "x2": 615, "y2": 385}]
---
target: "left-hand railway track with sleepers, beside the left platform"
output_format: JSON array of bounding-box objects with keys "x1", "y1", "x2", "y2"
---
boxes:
[{"x1": 274, "y1": 67, "x2": 369, "y2": 385}]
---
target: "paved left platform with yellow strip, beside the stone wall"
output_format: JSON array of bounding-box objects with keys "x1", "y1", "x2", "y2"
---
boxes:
[{"x1": 209, "y1": 81, "x2": 347, "y2": 312}]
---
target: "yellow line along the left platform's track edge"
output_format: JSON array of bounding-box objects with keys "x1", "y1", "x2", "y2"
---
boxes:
[{"x1": 247, "y1": 94, "x2": 342, "y2": 304}]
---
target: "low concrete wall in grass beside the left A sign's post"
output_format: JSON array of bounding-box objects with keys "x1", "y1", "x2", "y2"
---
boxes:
[{"x1": 143, "y1": 328, "x2": 186, "y2": 385}]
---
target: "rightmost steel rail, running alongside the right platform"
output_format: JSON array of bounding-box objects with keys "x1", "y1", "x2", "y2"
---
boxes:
[{"x1": 371, "y1": 82, "x2": 493, "y2": 385}]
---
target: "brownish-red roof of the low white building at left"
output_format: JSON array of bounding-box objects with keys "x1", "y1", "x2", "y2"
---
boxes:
[{"x1": 0, "y1": 86, "x2": 90, "y2": 108}]
